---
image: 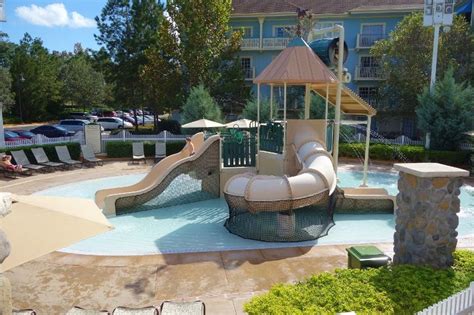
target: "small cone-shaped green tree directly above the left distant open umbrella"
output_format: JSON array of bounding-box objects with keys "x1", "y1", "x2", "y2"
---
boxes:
[{"x1": 182, "y1": 84, "x2": 222, "y2": 123}]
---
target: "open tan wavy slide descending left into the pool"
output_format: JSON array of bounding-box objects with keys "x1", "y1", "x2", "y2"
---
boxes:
[{"x1": 95, "y1": 132, "x2": 220, "y2": 216}]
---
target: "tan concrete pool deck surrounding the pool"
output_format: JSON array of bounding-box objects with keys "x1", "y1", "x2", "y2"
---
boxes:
[{"x1": 0, "y1": 162, "x2": 474, "y2": 314}]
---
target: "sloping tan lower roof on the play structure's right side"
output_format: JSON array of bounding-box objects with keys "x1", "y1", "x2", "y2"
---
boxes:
[{"x1": 312, "y1": 84, "x2": 377, "y2": 116}]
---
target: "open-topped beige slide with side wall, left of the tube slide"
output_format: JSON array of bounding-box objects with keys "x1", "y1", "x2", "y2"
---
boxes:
[{"x1": 95, "y1": 132, "x2": 220, "y2": 216}]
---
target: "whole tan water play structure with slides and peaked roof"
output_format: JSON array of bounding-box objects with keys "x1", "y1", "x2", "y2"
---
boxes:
[{"x1": 95, "y1": 34, "x2": 393, "y2": 241}]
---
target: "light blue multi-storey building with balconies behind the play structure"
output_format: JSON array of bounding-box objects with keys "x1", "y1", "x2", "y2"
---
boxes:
[{"x1": 231, "y1": 0, "x2": 423, "y2": 135}]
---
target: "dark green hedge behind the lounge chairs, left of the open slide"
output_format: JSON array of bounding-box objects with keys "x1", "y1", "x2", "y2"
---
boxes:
[{"x1": 105, "y1": 141, "x2": 185, "y2": 158}]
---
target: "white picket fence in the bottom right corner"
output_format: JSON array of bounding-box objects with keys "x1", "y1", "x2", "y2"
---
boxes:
[{"x1": 417, "y1": 282, "x2": 474, "y2": 315}]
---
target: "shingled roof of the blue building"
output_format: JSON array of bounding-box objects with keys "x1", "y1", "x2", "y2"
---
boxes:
[{"x1": 232, "y1": 0, "x2": 423, "y2": 15}]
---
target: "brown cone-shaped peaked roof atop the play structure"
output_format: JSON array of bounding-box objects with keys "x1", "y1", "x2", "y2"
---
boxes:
[{"x1": 254, "y1": 37, "x2": 337, "y2": 85}]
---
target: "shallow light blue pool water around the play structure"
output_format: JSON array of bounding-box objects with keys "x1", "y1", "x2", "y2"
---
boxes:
[{"x1": 38, "y1": 170, "x2": 474, "y2": 255}]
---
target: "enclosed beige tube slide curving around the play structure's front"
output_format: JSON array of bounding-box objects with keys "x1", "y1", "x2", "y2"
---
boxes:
[{"x1": 224, "y1": 126, "x2": 337, "y2": 212}]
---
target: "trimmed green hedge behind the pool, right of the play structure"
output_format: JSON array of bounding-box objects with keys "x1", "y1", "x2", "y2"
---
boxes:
[{"x1": 339, "y1": 143, "x2": 471, "y2": 165}]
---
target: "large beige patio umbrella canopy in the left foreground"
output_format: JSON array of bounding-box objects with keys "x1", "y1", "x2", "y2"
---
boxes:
[{"x1": 0, "y1": 195, "x2": 113, "y2": 273}]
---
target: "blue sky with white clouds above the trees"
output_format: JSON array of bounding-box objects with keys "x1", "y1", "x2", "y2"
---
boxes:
[{"x1": 0, "y1": 0, "x2": 106, "y2": 51}]
